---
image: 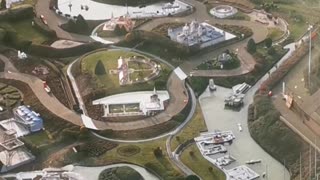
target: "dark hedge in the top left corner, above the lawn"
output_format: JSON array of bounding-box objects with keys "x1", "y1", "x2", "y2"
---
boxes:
[{"x1": 0, "y1": 4, "x2": 34, "y2": 21}]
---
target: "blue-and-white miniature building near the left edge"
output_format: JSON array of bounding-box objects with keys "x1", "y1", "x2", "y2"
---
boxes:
[{"x1": 13, "y1": 106, "x2": 43, "y2": 132}]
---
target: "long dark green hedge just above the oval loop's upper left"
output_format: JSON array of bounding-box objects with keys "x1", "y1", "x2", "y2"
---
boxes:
[{"x1": 28, "y1": 42, "x2": 107, "y2": 58}]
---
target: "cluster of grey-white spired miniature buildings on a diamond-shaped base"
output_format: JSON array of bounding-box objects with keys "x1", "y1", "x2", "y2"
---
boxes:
[{"x1": 168, "y1": 21, "x2": 236, "y2": 48}]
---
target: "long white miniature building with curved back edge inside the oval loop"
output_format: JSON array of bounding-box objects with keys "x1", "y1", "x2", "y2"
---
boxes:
[{"x1": 92, "y1": 89, "x2": 169, "y2": 117}]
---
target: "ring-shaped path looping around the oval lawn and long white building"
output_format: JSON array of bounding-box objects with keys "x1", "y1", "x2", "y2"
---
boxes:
[{"x1": 67, "y1": 48, "x2": 188, "y2": 130}]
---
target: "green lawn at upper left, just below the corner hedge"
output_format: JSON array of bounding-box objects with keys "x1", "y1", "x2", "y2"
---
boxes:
[{"x1": 0, "y1": 19, "x2": 49, "y2": 44}]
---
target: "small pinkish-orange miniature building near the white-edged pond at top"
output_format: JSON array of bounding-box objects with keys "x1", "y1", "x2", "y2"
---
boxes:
[{"x1": 102, "y1": 15, "x2": 135, "y2": 32}]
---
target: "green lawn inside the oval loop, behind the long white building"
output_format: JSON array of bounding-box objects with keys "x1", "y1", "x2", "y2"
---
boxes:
[{"x1": 81, "y1": 50, "x2": 171, "y2": 95}]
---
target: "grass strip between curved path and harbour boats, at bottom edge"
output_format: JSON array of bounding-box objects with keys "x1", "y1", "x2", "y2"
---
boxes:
[{"x1": 180, "y1": 144, "x2": 226, "y2": 180}]
